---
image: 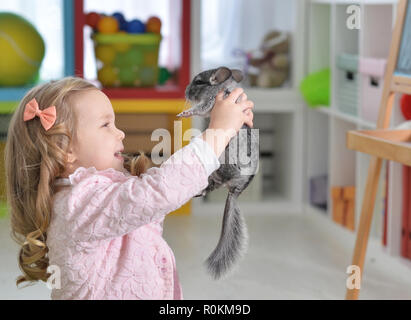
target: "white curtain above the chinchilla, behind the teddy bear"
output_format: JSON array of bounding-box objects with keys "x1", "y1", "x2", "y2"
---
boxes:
[{"x1": 201, "y1": 0, "x2": 299, "y2": 69}]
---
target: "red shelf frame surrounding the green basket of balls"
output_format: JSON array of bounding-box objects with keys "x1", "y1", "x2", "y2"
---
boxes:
[{"x1": 75, "y1": 0, "x2": 191, "y2": 99}]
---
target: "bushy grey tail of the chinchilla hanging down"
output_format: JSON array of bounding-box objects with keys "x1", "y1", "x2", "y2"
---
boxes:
[{"x1": 206, "y1": 192, "x2": 248, "y2": 280}]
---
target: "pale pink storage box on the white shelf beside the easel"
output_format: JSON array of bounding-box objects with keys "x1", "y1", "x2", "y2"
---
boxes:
[{"x1": 359, "y1": 58, "x2": 387, "y2": 123}]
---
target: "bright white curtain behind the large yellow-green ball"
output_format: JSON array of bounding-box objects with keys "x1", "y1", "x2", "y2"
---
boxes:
[{"x1": 0, "y1": 0, "x2": 64, "y2": 81}]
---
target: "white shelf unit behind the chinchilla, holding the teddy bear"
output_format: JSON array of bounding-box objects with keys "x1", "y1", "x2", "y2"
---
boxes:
[{"x1": 191, "y1": 0, "x2": 306, "y2": 213}]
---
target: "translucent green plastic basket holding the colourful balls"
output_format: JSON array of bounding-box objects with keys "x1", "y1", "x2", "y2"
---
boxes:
[{"x1": 92, "y1": 33, "x2": 161, "y2": 87}]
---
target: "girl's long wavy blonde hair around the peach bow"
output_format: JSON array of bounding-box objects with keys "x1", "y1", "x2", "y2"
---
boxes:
[{"x1": 5, "y1": 77, "x2": 149, "y2": 285}]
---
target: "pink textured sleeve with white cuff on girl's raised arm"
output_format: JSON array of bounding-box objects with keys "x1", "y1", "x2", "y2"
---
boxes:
[{"x1": 62, "y1": 138, "x2": 220, "y2": 241}]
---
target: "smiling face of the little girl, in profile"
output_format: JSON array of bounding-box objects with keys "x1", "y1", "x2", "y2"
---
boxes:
[{"x1": 67, "y1": 90, "x2": 125, "y2": 176}]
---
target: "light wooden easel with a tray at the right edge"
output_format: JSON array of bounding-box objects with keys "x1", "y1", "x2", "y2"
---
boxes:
[{"x1": 346, "y1": 0, "x2": 411, "y2": 300}]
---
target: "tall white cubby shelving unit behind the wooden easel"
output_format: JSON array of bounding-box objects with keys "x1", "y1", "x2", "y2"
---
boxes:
[{"x1": 304, "y1": 0, "x2": 404, "y2": 256}]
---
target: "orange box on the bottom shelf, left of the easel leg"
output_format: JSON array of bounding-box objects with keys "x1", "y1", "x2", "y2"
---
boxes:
[{"x1": 331, "y1": 186, "x2": 355, "y2": 231}]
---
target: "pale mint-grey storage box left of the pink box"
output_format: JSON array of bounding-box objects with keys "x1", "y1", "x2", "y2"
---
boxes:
[{"x1": 336, "y1": 53, "x2": 359, "y2": 116}]
